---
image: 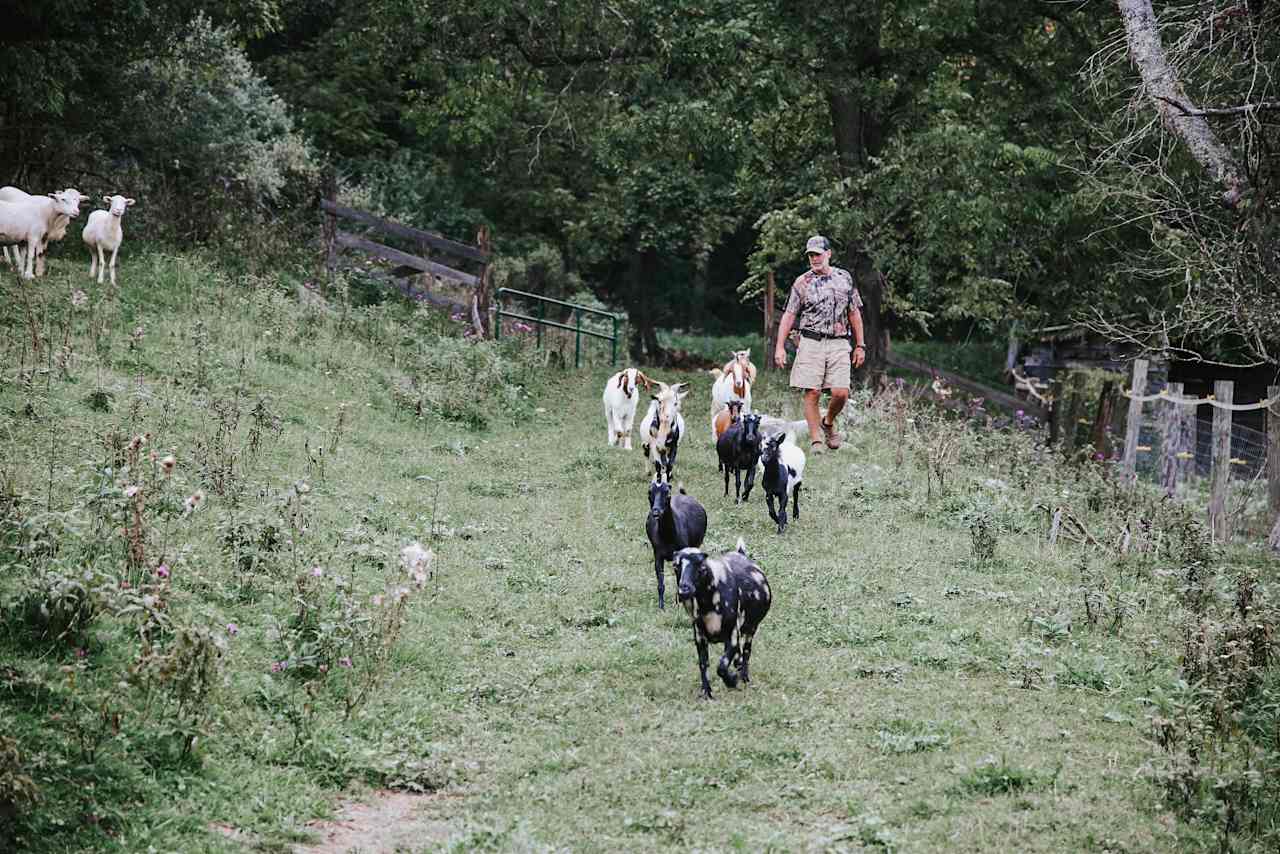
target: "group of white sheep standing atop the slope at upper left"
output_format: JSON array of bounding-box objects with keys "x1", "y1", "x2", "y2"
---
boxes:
[{"x1": 0, "y1": 187, "x2": 134, "y2": 284}]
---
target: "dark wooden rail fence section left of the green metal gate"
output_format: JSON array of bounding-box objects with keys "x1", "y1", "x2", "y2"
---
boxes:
[{"x1": 320, "y1": 197, "x2": 492, "y2": 335}]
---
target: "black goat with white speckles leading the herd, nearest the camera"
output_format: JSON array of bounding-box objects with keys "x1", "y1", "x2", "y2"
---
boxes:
[{"x1": 673, "y1": 536, "x2": 773, "y2": 699}]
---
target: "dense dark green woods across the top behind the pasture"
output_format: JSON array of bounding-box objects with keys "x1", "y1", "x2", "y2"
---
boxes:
[{"x1": 0, "y1": 0, "x2": 1280, "y2": 364}]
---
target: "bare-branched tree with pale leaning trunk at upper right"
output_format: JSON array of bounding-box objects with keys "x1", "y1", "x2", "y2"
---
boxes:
[{"x1": 1091, "y1": 0, "x2": 1280, "y2": 365}]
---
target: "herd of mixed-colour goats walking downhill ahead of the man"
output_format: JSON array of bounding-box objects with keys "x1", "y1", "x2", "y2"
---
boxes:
[{"x1": 604, "y1": 350, "x2": 805, "y2": 699}]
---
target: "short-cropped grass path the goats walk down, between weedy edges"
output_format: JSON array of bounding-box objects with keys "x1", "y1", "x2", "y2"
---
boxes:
[{"x1": 368, "y1": 370, "x2": 1172, "y2": 851}]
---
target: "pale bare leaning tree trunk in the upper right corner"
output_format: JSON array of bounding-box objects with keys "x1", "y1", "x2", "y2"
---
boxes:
[{"x1": 1116, "y1": 0, "x2": 1247, "y2": 207}]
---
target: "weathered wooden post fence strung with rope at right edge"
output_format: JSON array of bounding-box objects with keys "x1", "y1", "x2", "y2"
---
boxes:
[{"x1": 1120, "y1": 359, "x2": 1280, "y2": 543}]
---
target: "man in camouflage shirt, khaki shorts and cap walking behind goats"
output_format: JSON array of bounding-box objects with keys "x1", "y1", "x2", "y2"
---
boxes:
[{"x1": 773, "y1": 234, "x2": 867, "y2": 453}]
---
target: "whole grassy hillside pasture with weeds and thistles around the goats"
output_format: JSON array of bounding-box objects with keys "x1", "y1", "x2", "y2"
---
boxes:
[{"x1": 0, "y1": 255, "x2": 1276, "y2": 851}]
